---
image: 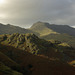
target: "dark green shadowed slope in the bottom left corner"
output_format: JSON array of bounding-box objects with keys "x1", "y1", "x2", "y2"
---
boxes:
[{"x1": 0, "y1": 51, "x2": 26, "y2": 75}]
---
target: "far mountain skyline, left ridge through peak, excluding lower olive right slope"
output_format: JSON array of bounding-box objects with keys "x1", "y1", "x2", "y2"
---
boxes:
[{"x1": 0, "y1": 22, "x2": 75, "y2": 36}]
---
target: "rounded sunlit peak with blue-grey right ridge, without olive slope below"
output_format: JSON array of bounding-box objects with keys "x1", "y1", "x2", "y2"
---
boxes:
[{"x1": 30, "y1": 22, "x2": 75, "y2": 36}]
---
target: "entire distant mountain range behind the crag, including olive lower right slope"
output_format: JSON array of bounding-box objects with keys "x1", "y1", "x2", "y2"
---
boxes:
[{"x1": 0, "y1": 22, "x2": 75, "y2": 47}]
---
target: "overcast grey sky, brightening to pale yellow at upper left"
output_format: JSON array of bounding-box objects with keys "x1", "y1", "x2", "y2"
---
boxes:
[{"x1": 0, "y1": 0, "x2": 75, "y2": 28}]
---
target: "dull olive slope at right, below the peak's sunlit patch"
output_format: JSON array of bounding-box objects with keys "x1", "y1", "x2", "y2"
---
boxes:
[{"x1": 41, "y1": 34, "x2": 75, "y2": 48}]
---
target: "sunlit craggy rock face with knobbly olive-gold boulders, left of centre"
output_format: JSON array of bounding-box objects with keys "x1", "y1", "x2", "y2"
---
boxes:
[{"x1": 1, "y1": 33, "x2": 45, "y2": 54}]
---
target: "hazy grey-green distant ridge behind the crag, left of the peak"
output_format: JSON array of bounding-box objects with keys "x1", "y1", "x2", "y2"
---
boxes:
[{"x1": 0, "y1": 23, "x2": 32, "y2": 34}]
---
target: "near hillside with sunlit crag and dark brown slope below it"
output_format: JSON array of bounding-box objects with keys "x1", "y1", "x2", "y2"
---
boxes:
[{"x1": 0, "y1": 33, "x2": 75, "y2": 75}]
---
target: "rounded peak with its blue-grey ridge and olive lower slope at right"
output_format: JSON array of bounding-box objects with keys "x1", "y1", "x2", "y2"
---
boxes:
[{"x1": 30, "y1": 22, "x2": 75, "y2": 47}]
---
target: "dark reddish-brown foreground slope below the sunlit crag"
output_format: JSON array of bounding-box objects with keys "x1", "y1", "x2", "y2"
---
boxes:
[{"x1": 0, "y1": 44, "x2": 75, "y2": 75}]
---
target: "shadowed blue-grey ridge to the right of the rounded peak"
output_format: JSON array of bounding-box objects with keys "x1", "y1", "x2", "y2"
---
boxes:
[{"x1": 46, "y1": 24, "x2": 75, "y2": 36}]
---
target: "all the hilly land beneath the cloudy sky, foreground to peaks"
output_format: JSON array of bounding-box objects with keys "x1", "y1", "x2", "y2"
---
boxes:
[{"x1": 0, "y1": 22, "x2": 75, "y2": 75}]
